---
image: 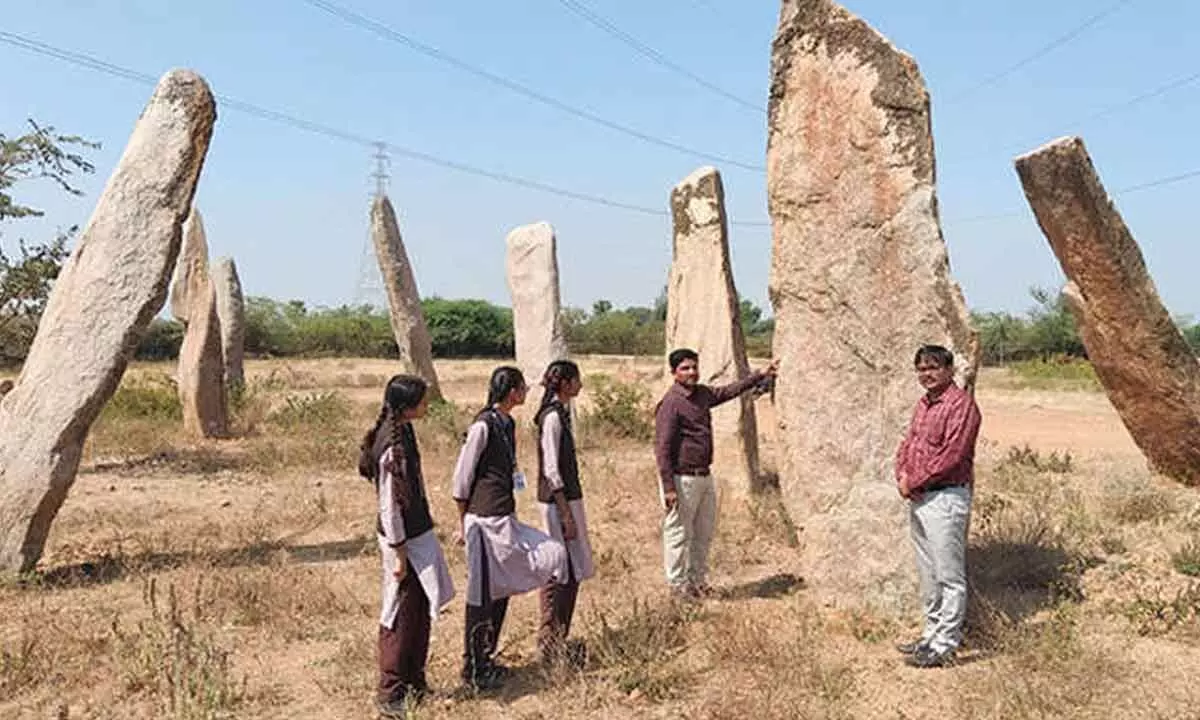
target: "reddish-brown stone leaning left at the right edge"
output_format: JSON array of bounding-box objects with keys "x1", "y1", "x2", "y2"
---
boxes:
[{"x1": 1016, "y1": 138, "x2": 1200, "y2": 485}]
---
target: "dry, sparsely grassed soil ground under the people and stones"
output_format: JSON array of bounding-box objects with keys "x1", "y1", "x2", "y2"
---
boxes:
[{"x1": 0, "y1": 358, "x2": 1200, "y2": 720}]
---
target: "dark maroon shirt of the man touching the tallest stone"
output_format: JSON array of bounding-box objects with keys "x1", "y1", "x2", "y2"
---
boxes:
[{"x1": 654, "y1": 373, "x2": 763, "y2": 488}]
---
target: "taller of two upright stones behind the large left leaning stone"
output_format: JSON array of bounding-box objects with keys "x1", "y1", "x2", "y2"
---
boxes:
[{"x1": 170, "y1": 209, "x2": 229, "y2": 438}]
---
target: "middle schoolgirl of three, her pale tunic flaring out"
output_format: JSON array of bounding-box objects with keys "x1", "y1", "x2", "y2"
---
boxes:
[{"x1": 454, "y1": 367, "x2": 568, "y2": 690}]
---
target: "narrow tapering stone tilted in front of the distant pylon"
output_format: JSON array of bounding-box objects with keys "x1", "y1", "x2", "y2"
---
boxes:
[{"x1": 371, "y1": 194, "x2": 442, "y2": 400}]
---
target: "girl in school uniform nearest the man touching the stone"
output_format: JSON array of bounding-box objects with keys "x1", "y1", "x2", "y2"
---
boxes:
[{"x1": 535, "y1": 360, "x2": 595, "y2": 667}]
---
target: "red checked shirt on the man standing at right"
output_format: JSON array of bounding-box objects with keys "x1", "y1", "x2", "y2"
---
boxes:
[{"x1": 896, "y1": 384, "x2": 982, "y2": 490}]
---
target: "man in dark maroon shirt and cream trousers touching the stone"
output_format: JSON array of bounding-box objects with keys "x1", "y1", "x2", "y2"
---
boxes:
[{"x1": 654, "y1": 348, "x2": 776, "y2": 599}]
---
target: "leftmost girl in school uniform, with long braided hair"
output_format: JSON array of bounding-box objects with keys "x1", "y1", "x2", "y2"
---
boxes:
[{"x1": 359, "y1": 376, "x2": 454, "y2": 718}]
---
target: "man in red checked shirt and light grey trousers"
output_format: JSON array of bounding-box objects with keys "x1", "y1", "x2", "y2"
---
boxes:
[{"x1": 896, "y1": 346, "x2": 980, "y2": 667}]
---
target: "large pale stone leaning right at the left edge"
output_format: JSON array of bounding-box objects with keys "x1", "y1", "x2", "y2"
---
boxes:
[{"x1": 0, "y1": 71, "x2": 216, "y2": 572}]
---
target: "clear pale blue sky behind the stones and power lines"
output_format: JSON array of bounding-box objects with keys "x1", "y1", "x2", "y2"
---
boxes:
[{"x1": 0, "y1": 0, "x2": 1200, "y2": 316}]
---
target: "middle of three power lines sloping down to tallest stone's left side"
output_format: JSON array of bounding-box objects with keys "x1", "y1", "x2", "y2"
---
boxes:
[{"x1": 300, "y1": 0, "x2": 767, "y2": 173}]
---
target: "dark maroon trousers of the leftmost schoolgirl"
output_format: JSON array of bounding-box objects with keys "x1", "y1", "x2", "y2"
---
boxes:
[{"x1": 378, "y1": 563, "x2": 430, "y2": 702}]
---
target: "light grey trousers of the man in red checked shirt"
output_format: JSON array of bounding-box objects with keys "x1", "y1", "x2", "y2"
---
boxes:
[{"x1": 908, "y1": 487, "x2": 971, "y2": 653}]
